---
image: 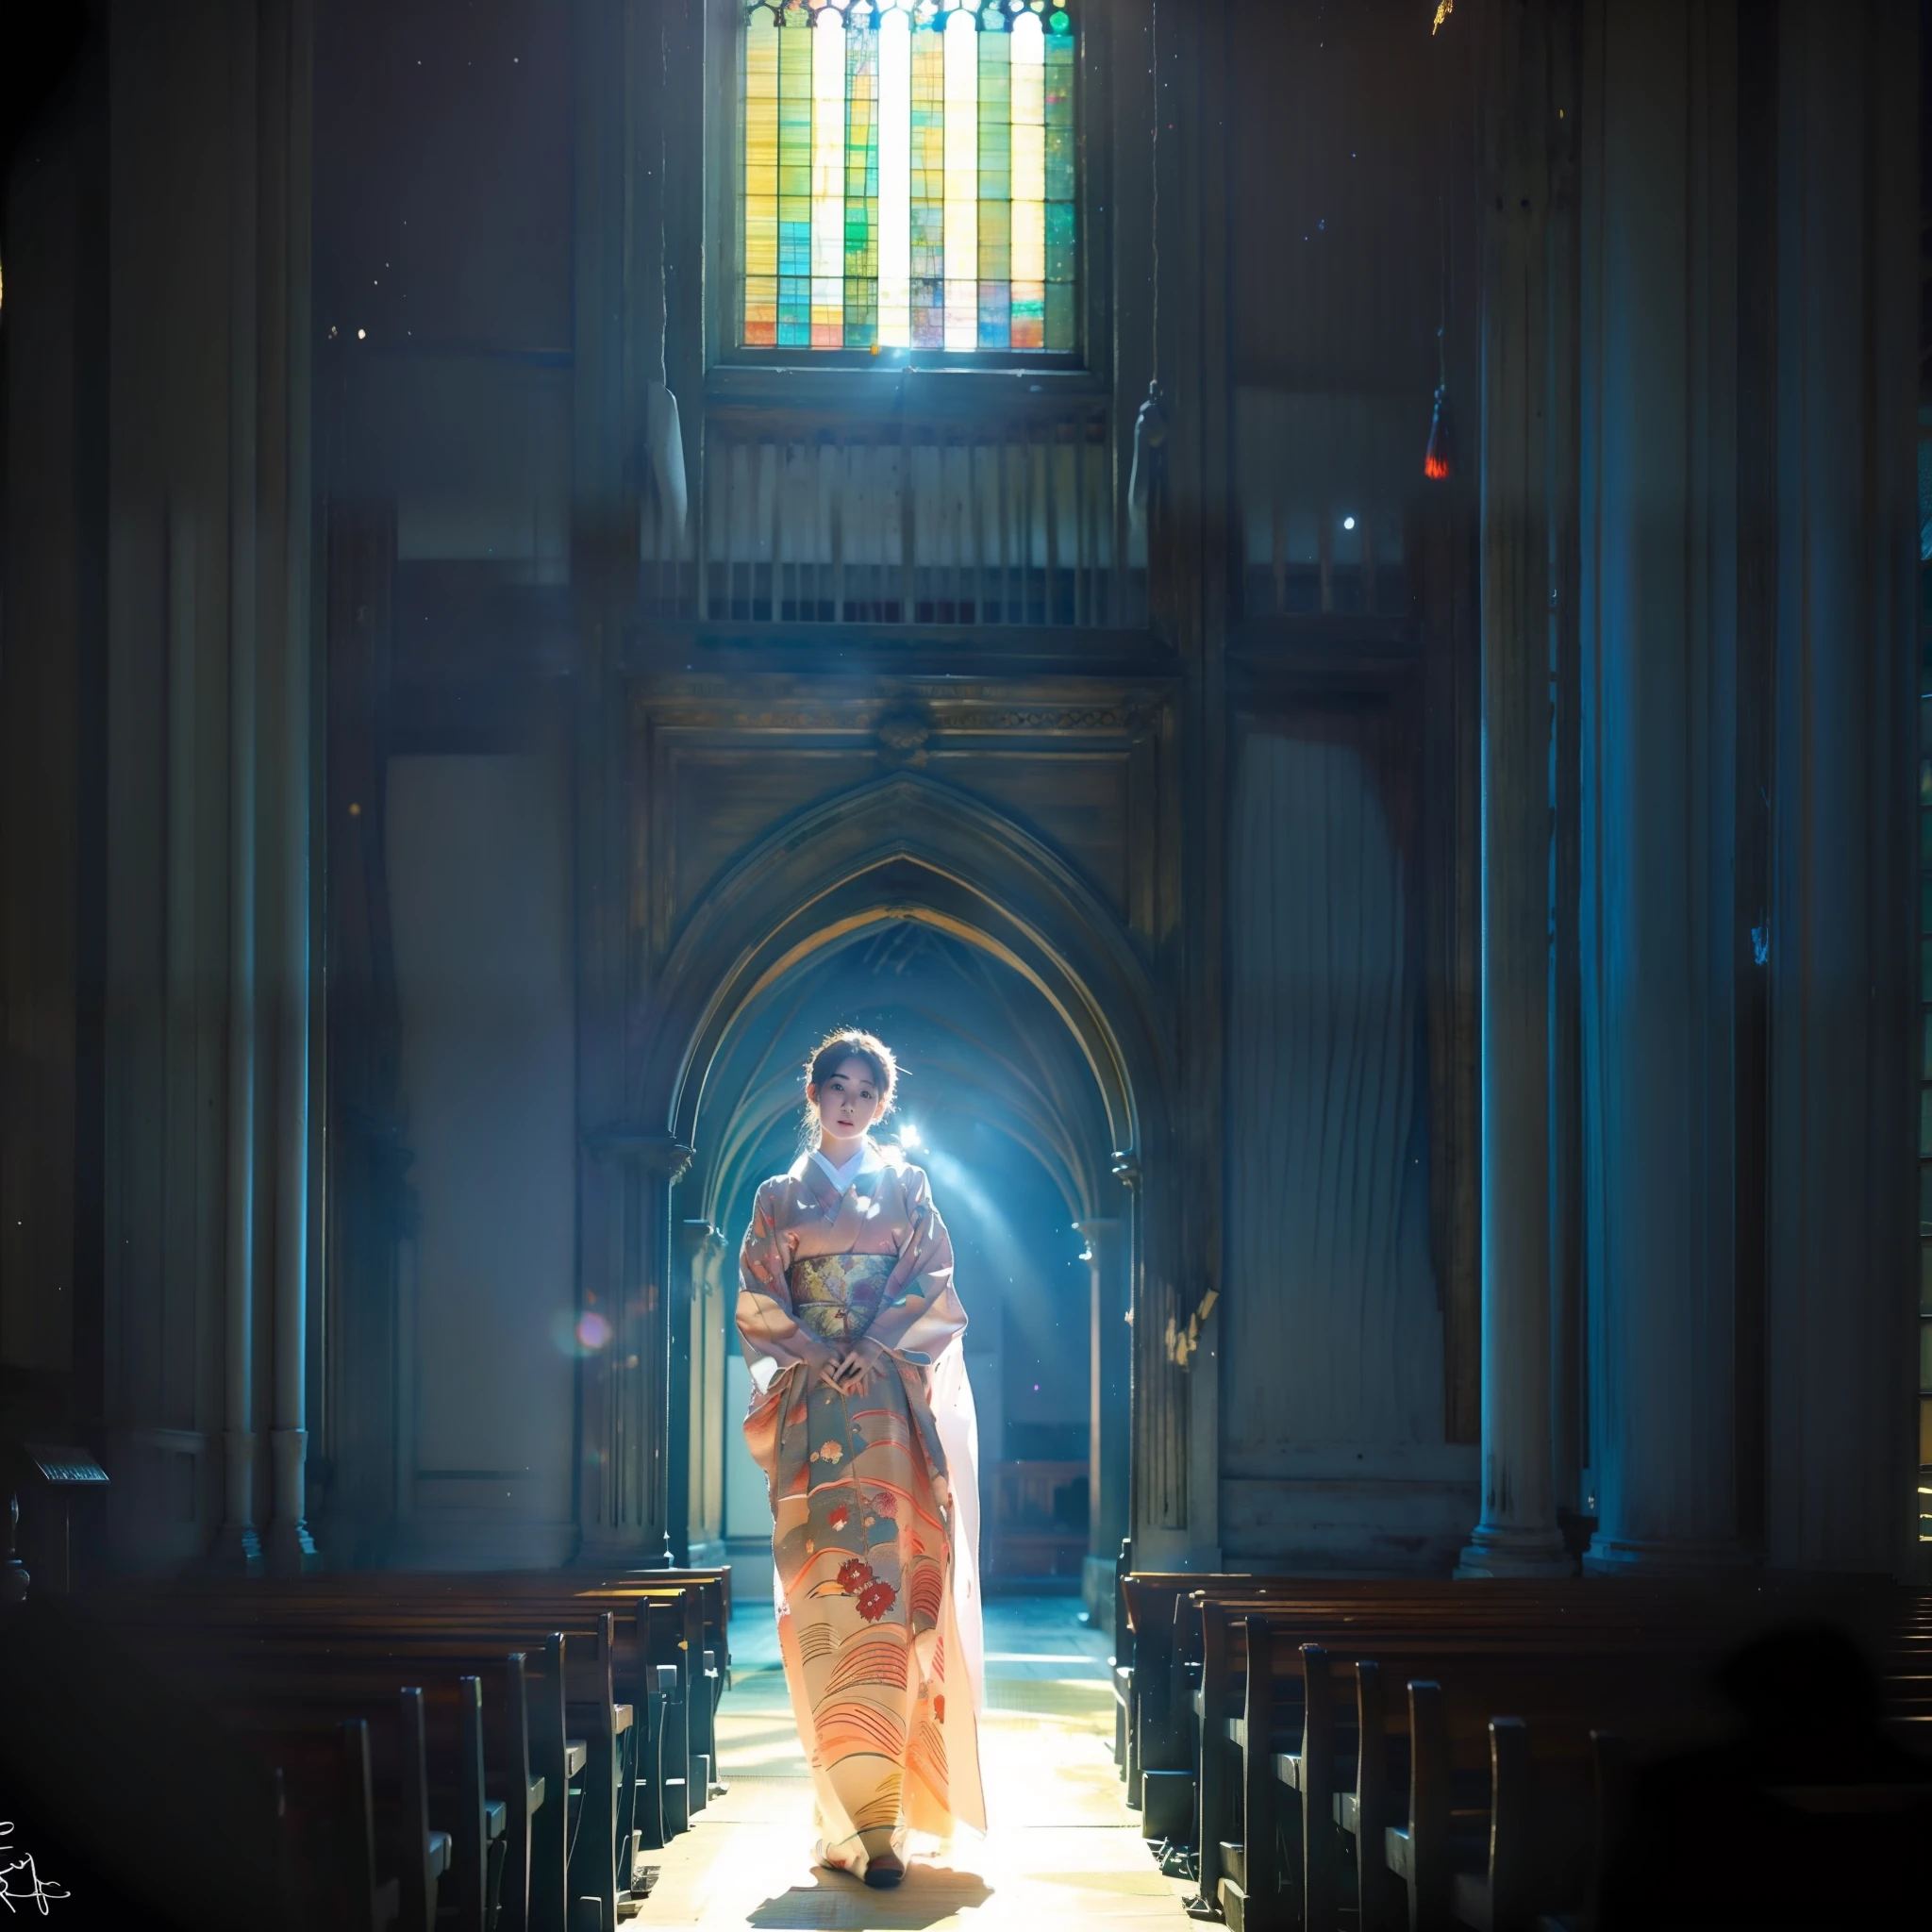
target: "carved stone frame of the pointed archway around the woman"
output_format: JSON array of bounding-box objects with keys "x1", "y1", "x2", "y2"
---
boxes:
[{"x1": 579, "y1": 771, "x2": 1189, "y2": 1584}]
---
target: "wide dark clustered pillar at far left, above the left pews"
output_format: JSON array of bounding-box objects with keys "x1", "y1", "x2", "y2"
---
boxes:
[{"x1": 93, "y1": 0, "x2": 315, "y2": 1573}]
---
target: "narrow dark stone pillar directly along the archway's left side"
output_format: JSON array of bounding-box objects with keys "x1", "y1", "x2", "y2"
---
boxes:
[{"x1": 568, "y1": 0, "x2": 660, "y2": 1565}]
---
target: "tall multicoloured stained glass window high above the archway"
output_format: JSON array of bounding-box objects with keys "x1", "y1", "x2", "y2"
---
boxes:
[{"x1": 738, "y1": 0, "x2": 1076, "y2": 354}]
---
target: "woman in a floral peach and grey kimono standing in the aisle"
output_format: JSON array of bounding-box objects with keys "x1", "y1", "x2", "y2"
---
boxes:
[{"x1": 738, "y1": 1032, "x2": 985, "y2": 1886}]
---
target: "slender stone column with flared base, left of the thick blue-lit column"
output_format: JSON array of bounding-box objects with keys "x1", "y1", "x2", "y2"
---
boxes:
[{"x1": 1457, "y1": 6, "x2": 1571, "y2": 1576}]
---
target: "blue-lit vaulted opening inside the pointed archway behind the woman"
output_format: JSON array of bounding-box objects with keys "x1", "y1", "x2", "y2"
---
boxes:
[{"x1": 680, "y1": 918, "x2": 1126, "y2": 1591}]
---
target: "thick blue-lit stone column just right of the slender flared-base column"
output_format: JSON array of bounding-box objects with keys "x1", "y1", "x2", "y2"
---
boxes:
[{"x1": 1582, "y1": 0, "x2": 1740, "y2": 1573}]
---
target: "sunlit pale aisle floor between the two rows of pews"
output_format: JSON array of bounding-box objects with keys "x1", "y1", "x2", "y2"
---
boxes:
[{"x1": 632, "y1": 1598, "x2": 1191, "y2": 1932}]
